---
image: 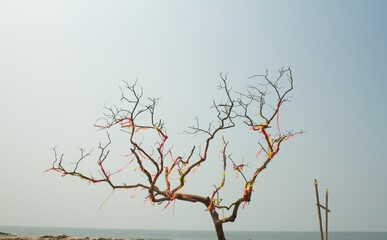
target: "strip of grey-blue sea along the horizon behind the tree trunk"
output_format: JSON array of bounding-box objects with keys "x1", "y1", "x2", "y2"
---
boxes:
[{"x1": 0, "y1": 226, "x2": 387, "y2": 240}]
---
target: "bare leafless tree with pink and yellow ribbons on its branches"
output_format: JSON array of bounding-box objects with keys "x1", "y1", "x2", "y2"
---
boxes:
[{"x1": 48, "y1": 68, "x2": 301, "y2": 239}]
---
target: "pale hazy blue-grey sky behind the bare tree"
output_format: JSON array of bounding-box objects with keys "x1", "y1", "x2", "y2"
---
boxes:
[{"x1": 0, "y1": 0, "x2": 387, "y2": 231}]
